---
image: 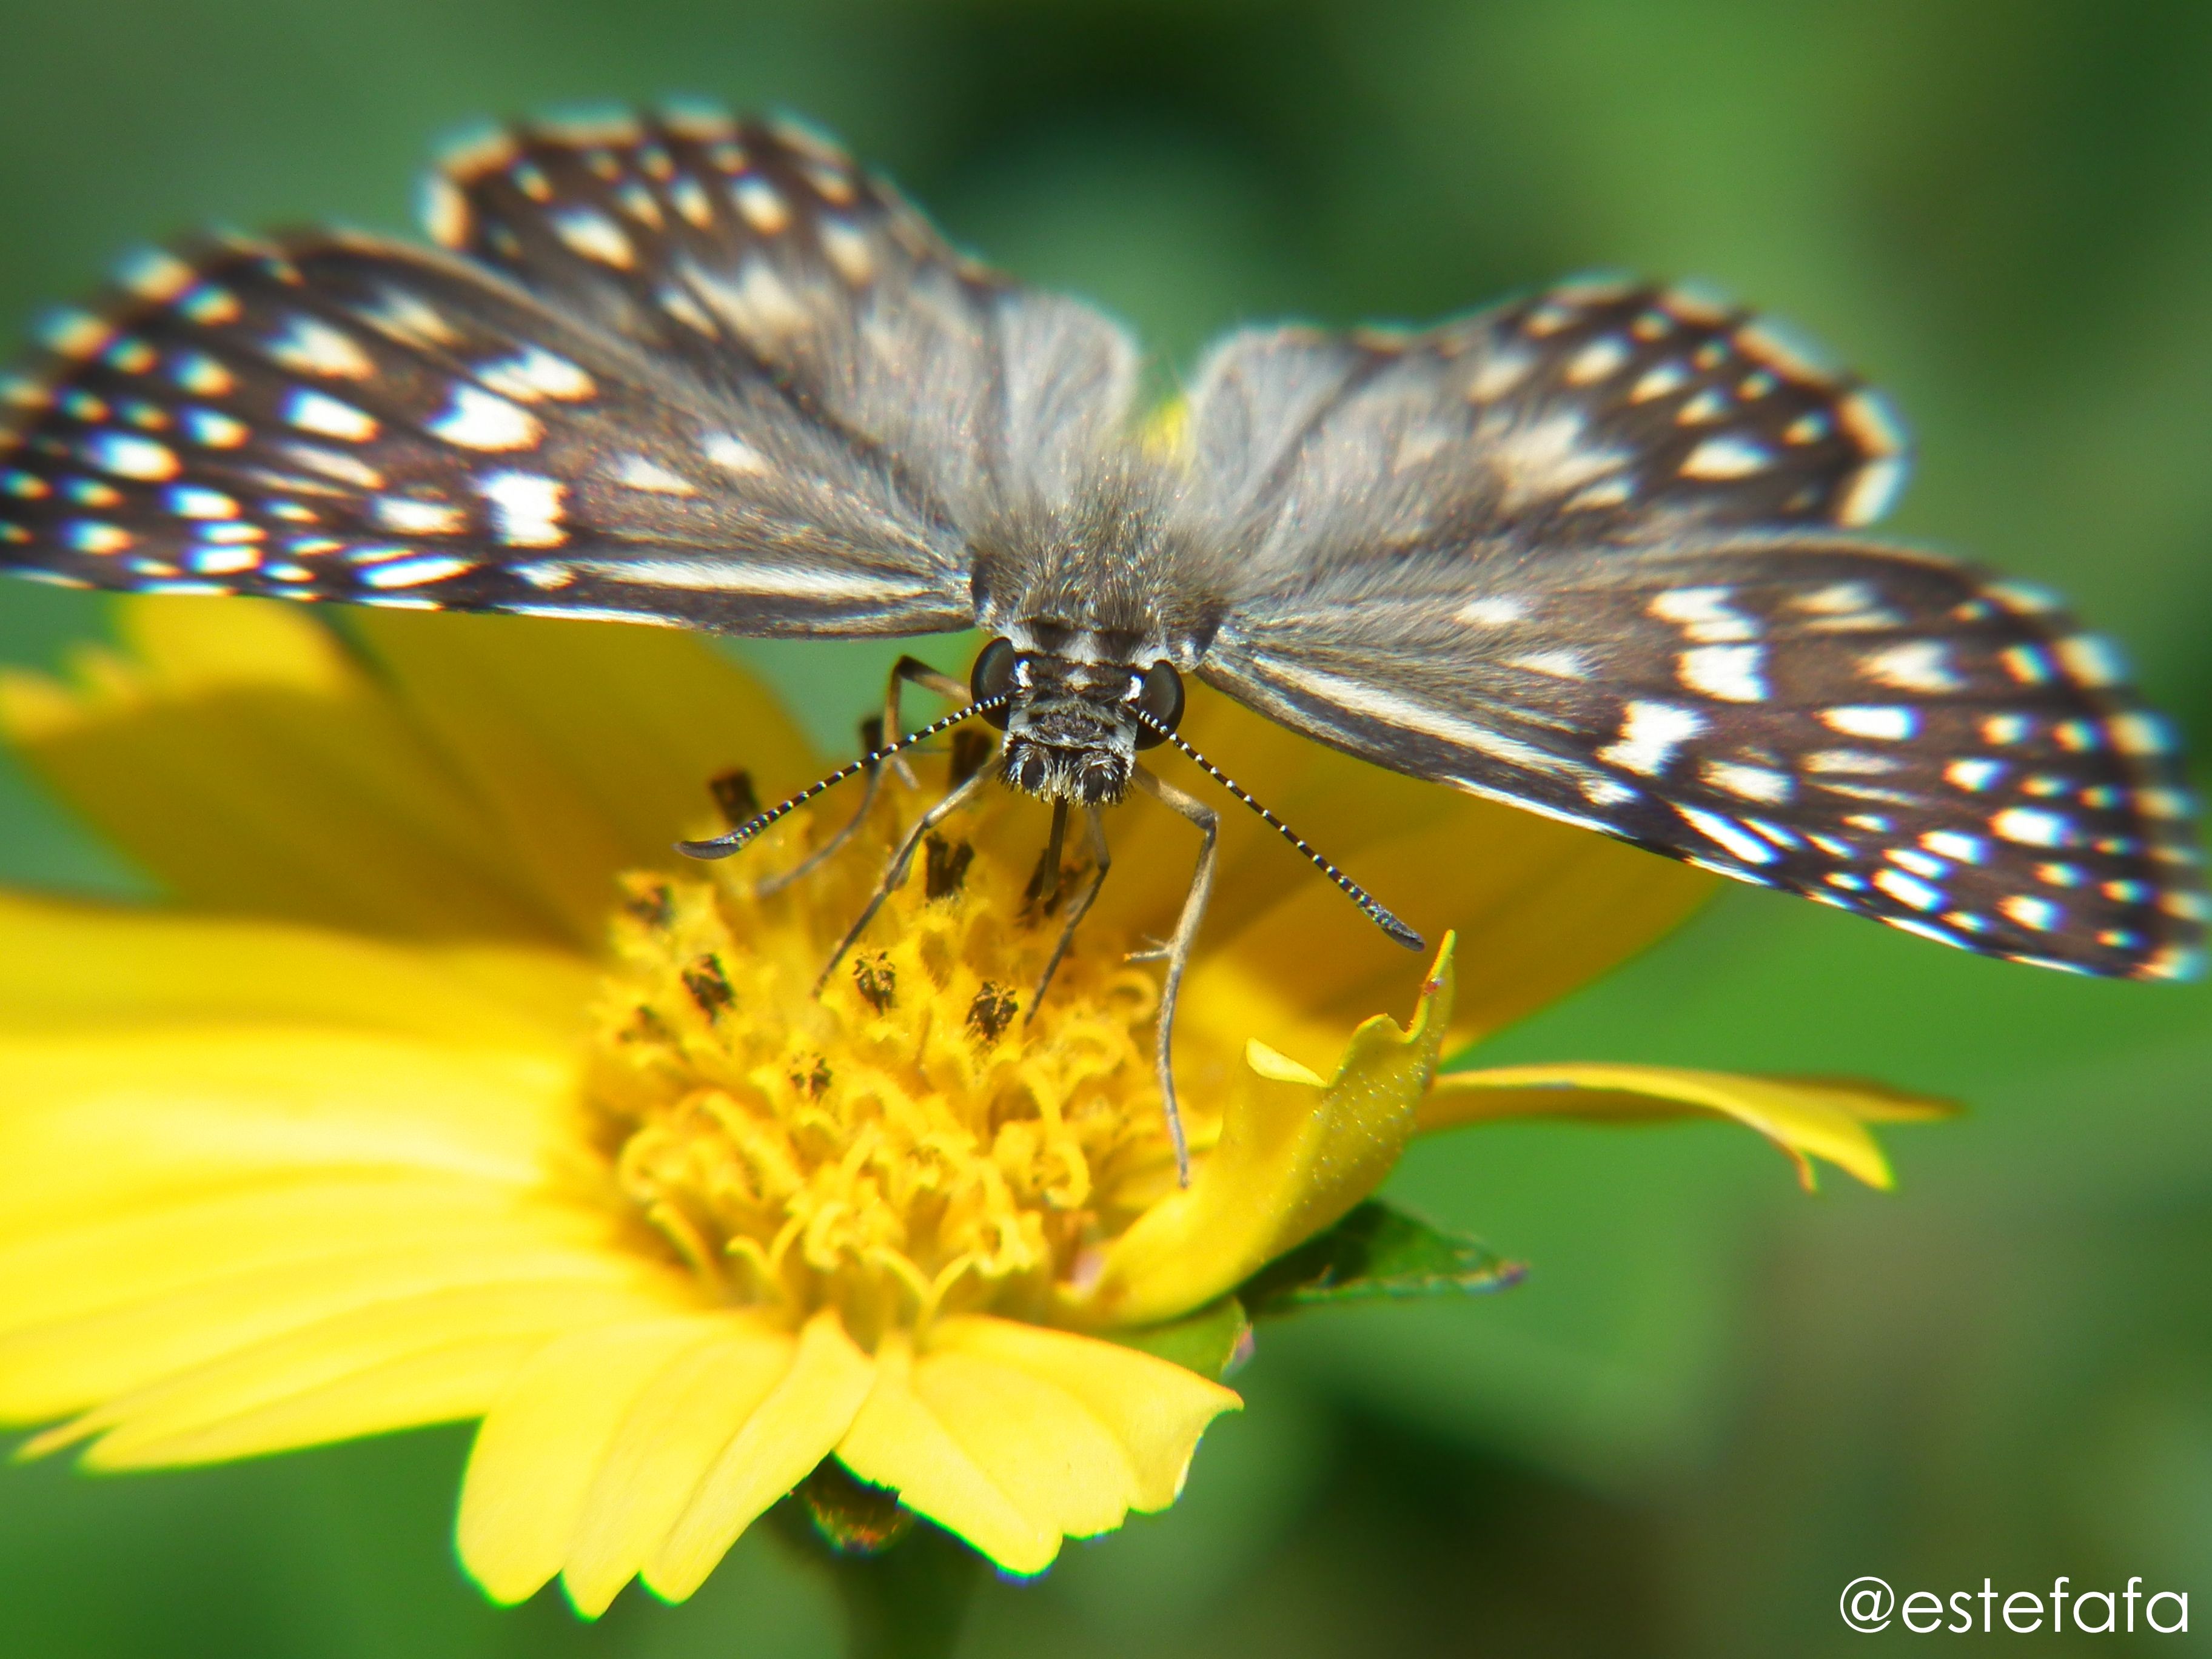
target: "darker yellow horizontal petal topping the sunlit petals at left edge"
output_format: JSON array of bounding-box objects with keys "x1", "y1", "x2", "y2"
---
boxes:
[{"x1": 0, "y1": 894, "x2": 593, "y2": 1047}]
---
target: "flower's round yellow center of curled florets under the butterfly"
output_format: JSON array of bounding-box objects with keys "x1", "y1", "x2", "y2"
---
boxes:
[{"x1": 588, "y1": 783, "x2": 1172, "y2": 1341}]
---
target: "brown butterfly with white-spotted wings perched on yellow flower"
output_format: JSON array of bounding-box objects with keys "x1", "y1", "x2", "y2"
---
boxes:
[{"x1": 0, "y1": 106, "x2": 2205, "y2": 1176}]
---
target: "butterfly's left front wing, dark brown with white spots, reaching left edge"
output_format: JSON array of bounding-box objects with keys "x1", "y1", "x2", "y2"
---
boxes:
[{"x1": 0, "y1": 232, "x2": 971, "y2": 632}]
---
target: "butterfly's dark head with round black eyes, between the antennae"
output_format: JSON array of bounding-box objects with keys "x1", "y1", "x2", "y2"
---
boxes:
[{"x1": 969, "y1": 639, "x2": 1184, "y2": 805}]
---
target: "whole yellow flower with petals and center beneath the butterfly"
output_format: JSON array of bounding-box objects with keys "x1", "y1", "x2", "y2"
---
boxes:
[{"x1": 0, "y1": 600, "x2": 1929, "y2": 1615}]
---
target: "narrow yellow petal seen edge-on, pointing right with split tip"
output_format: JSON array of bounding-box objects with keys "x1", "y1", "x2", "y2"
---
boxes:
[{"x1": 1420, "y1": 1066, "x2": 1957, "y2": 1190}]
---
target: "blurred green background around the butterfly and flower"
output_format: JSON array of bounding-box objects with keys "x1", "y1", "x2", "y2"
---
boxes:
[{"x1": 0, "y1": 0, "x2": 2212, "y2": 1659}]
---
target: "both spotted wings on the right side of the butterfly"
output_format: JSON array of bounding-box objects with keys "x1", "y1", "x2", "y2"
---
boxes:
[{"x1": 1188, "y1": 287, "x2": 2205, "y2": 977}]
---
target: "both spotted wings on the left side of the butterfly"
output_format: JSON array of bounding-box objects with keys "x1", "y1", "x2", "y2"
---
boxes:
[{"x1": 0, "y1": 106, "x2": 1128, "y2": 635}]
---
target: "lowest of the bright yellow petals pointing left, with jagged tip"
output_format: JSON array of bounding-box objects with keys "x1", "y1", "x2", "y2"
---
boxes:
[{"x1": 32, "y1": 1276, "x2": 663, "y2": 1469}]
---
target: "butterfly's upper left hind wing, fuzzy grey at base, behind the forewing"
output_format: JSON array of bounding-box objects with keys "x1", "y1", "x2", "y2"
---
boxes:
[{"x1": 424, "y1": 106, "x2": 1137, "y2": 535}]
